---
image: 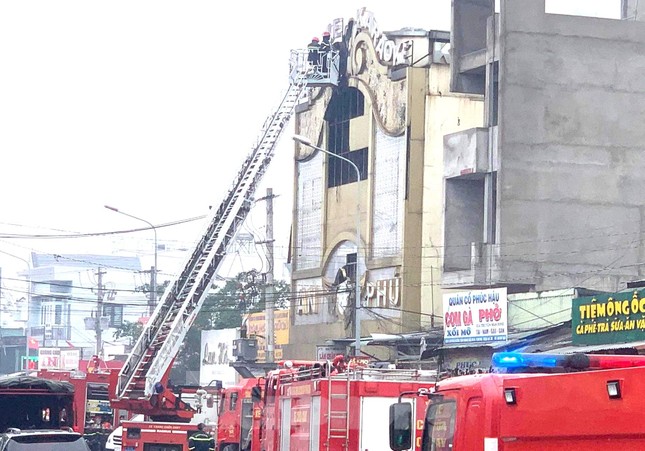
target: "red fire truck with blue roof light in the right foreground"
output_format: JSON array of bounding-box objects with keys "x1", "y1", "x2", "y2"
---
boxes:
[{"x1": 390, "y1": 353, "x2": 645, "y2": 451}]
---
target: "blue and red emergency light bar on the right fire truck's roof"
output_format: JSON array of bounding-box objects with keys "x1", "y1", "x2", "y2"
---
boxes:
[{"x1": 492, "y1": 352, "x2": 645, "y2": 370}]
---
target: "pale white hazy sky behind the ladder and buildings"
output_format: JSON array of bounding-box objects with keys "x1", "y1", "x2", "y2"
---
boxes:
[{"x1": 0, "y1": 0, "x2": 619, "y2": 290}]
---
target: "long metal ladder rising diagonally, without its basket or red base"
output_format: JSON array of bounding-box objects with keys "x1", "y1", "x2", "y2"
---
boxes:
[{"x1": 116, "y1": 60, "x2": 307, "y2": 400}]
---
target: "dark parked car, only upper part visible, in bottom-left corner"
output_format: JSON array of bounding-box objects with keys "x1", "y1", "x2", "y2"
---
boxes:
[{"x1": 0, "y1": 428, "x2": 90, "y2": 451}]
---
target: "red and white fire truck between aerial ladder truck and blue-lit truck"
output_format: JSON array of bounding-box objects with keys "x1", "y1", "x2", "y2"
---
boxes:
[{"x1": 218, "y1": 361, "x2": 436, "y2": 451}]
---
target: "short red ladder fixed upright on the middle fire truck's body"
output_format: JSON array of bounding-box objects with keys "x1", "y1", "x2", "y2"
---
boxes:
[{"x1": 327, "y1": 372, "x2": 351, "y2": 450}]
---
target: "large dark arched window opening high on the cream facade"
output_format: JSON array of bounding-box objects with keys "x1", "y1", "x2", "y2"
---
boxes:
[{"x1": 325, "y1": 88, "x2": 368, "y2": 188}]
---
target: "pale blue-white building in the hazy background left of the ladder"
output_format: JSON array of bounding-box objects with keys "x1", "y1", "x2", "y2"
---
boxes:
[{"x1": 27, "y1": 253, "x2": 149, "y2": 359}]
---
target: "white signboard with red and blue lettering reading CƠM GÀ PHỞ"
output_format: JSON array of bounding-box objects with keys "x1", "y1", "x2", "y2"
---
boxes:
[{"x1": 443, "y1": 288, "x2": 508, "y2": 344}]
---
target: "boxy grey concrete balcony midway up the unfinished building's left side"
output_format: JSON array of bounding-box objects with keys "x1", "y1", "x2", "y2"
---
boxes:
[{"x1": 443, "y1": 127, "x2": 497, "y2": 178}]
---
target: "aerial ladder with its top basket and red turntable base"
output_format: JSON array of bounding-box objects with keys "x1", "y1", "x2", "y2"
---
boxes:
[{"x1": 110, "y1": 46, "x2": 339, "y2": 451}]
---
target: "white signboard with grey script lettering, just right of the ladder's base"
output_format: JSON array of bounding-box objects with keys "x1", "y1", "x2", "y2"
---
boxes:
[{"x1": 199, "y1": 328, "x2": 240, "y2": 387}]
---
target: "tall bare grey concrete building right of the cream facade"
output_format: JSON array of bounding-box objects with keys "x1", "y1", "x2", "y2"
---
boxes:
[{"x1": 442, "y1": 0, "x2": 645, "y2": 292}]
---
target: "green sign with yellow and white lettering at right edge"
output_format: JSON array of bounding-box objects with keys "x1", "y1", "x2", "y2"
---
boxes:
[{"x1": 571, "y1": 289, "x2": 645, "y2": 345}]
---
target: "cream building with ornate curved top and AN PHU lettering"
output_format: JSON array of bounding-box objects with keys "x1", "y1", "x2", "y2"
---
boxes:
[{"x1": 285, "y1": 9, "x2": 483, "y2": 358}]
